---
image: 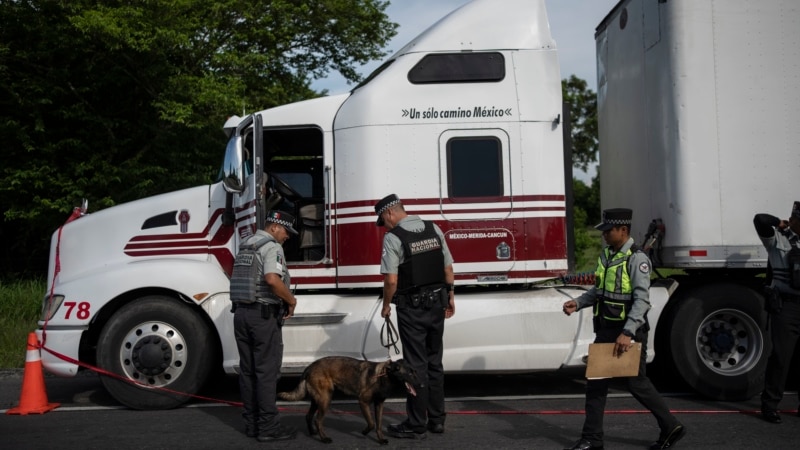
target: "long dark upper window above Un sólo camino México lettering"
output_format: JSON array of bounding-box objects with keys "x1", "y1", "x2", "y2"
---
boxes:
[{"x1": 408, "y1": 52, "x2": 506, "y2": 84}]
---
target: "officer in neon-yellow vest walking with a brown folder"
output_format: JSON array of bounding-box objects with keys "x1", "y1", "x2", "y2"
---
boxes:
[{"x1": 563, "y1": 208, "x2": 686, "y2": 450}]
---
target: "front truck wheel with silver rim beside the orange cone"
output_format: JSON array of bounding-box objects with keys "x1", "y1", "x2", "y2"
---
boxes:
[{"x1": 97, "y1": 295, "x2": 216, "y2": 409}]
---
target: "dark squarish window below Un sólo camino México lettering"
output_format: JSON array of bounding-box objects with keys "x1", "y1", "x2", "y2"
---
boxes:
[{"x1": 447, "y1": 137, "x2": 503, "y2": 201}]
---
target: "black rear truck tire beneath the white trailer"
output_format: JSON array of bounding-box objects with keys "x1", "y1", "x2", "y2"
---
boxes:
[{"x1": 669, "y1": 283, "x2": 769, "y2": 401}]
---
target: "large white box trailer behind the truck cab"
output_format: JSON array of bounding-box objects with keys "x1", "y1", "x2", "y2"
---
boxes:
[{"x1": 596, "y1": 0, "x2": 800, "y2": 267}]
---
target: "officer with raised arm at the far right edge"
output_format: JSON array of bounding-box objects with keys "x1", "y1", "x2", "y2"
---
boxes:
[{"x1": 753, "y1": 202, "x2": 800, "y2": 423}]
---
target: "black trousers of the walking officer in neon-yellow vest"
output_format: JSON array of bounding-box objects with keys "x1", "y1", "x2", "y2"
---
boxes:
[{"x1": 582, "y1": 328, "x2": 679, "y2": 446}]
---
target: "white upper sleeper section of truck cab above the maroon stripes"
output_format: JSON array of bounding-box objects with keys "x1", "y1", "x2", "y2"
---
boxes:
[{"x1": 334, "y1": 0, "x2": 564, "y2": 209}]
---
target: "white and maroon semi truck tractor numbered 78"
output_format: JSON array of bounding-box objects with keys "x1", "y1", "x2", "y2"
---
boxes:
[{"x1": 37, "y1": 0, "x2": 780, "y2": 409}]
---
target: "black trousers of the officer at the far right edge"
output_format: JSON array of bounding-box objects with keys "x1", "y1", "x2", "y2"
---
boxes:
[{"x1": 761, "y1": 300, "x2": 800, "y2": 411}]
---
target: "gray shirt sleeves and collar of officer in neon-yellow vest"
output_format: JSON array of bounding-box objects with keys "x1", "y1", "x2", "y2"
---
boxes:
[{"x1": 575, "y1": 238, "x2": 651, "y2": 334}]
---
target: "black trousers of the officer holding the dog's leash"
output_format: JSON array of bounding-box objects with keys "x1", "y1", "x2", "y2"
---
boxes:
[{"x1": 397, "y1": 306, "x2": 446, "y2": 433}]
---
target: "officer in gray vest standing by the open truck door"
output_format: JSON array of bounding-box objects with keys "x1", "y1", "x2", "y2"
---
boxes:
[{"x1": 230, "y1": 211, "x2": 297, "y2": 442}]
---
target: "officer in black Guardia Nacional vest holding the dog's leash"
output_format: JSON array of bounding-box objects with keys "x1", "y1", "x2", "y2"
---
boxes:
[{"x1": 375, "y1": 194, "x2": 456, "y2": 439}]
